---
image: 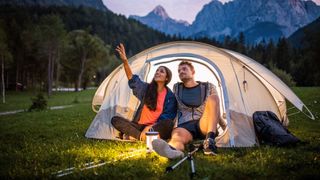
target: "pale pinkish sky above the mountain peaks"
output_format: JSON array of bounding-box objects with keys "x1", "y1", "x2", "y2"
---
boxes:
[{"x1": 103, "y1": 0, "x2": 320, "y2": 24}]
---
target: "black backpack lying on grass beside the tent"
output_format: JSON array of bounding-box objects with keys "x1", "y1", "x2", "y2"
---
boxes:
[{"x1": 253, "y1": 111, "x2": 300, "y2": 146}]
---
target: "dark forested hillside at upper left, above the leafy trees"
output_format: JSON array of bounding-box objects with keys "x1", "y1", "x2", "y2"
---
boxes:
[{"x1": 0, "y1": 5, "x2": 170, "y2": 55}]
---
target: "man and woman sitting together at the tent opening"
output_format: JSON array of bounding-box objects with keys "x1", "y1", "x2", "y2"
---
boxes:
[{"x1": 111, "y1": 44, "x2": 220, "y2": 159}]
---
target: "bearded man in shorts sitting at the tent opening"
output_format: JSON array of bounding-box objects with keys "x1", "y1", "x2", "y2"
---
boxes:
[{"x1": 152, "y1": 61, "x2": 220, "y2": 159}]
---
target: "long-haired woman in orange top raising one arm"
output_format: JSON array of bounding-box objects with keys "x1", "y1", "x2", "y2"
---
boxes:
[{"x1": 111, "y1": 44, "x2": 177, "y2": 141}]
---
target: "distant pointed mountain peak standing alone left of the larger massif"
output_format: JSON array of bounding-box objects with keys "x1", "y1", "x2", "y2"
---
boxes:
[{"x1": 129, "y1": 5, "x2": 189, "y2": 35}]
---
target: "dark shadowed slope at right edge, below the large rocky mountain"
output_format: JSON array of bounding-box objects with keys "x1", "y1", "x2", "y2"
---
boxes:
[{"x1": 288, "y1": 17, "x2": 320, "y2": 48}]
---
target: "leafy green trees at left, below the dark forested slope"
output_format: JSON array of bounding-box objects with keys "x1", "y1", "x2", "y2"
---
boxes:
[{"x1": 0, "y1": 14, "x2": 116, "y2": 96}]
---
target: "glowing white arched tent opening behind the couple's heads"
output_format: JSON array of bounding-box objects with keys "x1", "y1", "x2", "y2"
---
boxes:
[{"x1": 145, "y1": 56, "x2": 227, "y2": 139}]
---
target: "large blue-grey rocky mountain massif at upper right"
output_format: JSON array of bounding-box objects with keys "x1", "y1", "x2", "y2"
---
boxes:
[{"x1": 185, "y1": 0, "x2": 320, "y2": 43}]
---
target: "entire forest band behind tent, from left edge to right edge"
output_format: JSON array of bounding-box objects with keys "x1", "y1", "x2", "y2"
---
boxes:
[{"x1": 0, "y1": 5, "x2": 320, "y2": 102}]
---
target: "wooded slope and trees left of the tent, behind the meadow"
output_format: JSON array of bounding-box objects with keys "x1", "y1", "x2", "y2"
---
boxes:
[{"x1": 0, "y1": 5, "x2": 174, "y2": 100}]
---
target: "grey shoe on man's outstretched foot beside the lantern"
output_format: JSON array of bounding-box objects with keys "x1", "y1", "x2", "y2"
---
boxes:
[{"x1": 152, "y1": 139, "x2": 184, "y2": 159}]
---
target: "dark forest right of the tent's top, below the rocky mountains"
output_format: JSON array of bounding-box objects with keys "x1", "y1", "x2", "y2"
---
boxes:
[{"x1": 181, "y1": 30, "x2": 320, "y2": 86}]
